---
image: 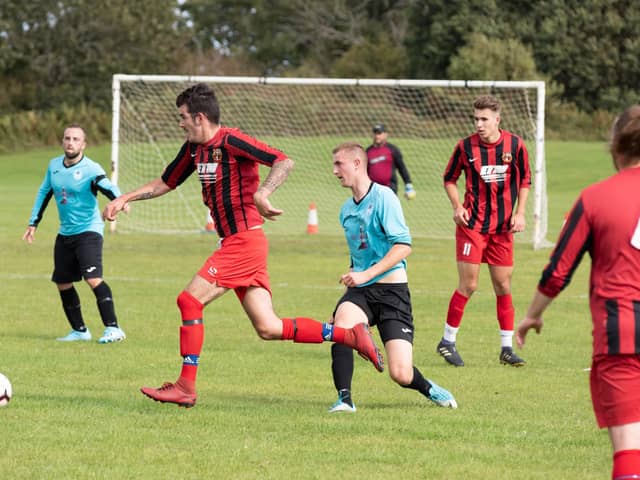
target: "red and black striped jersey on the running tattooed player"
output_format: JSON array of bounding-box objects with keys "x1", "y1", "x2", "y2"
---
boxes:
[{"x1": 162, "y1": 127, "x2": 287, "y2": 237}]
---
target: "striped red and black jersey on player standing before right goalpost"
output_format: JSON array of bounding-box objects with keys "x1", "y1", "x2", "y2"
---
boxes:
[{"x1": 444, "y1": 130, "x2": 531, "y2": 233}]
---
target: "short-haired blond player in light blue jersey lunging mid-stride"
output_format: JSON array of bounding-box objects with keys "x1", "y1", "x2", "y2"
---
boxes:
[{"x1": 329, "y1": 143, "x2": 457, "y2": 413}]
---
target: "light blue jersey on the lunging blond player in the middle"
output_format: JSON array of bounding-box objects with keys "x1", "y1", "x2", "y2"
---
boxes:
[{"x1": 340, "y1": 183, "x2": 411, "y2": 287}]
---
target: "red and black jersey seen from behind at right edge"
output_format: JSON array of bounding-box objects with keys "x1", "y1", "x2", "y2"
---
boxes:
[{"x1": 538, "y1": 168, "x2": 640, "y2": 356}]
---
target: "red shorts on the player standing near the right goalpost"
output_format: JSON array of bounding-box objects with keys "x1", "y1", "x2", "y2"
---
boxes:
[{"x1": 456, "y1": 225, "x2": 513, "y2": 267}]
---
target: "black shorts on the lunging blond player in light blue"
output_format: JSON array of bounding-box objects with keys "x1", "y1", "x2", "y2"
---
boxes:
[{"x1": 333, "y1": 283, "x2": 413, "y2": 344}]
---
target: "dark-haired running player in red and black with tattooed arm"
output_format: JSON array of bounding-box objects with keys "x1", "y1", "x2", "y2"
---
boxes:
[{"x1": 103, "y1": 84, "x2": 383, "y2": 407}]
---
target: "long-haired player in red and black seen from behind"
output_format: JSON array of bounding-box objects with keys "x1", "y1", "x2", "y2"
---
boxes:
[{"x1": 516, "y1": 105, "x2": 640, "y2": 480}]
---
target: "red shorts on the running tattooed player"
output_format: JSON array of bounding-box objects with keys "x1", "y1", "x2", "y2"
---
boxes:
[{"x1": 198, "y1": 228, "x2": 271, "y2": 302}]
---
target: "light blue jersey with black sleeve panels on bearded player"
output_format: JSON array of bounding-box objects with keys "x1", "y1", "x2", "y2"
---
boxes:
[{"x1": 29, "y1": 155, "x2": 120, "y2": 235}]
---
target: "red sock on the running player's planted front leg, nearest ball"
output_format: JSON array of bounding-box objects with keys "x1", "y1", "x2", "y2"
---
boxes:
[{"x1": 178, "y1": 291, "x2": 204, "y2": 382}]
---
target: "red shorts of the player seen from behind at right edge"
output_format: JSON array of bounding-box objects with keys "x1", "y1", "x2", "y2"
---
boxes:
[{"x1": 591, "y1": 354, "x2": 640, "y2": 428}]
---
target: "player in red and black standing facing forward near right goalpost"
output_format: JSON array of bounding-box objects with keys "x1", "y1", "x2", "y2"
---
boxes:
[{"x1": 437, "y1": 95, "x2": 531, "y2": 367}]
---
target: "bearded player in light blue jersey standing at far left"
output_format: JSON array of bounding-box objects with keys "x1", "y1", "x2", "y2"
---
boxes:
[{"x1": 22, "y1": 124, "x2": 125, "y2": 343}]
